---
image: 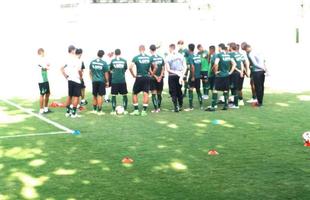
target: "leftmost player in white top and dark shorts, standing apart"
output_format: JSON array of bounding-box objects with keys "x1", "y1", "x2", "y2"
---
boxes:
[{"x1": 37, "y1": 48, "x2": 51, "y2": 114}]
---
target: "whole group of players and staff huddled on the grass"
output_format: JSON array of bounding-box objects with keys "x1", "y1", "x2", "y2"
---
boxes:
[{"x1": 38, "y1": 41, "x2": 266, "y2": 118}]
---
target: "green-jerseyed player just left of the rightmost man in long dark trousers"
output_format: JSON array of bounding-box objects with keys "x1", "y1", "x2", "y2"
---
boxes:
[{"x1": 229, "y1": 42, "x2": 244, "y2": 108}]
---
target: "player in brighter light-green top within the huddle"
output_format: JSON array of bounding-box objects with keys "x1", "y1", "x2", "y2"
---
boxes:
[{"x1": 197, "y1": 44, "x2": 210, "y2": 100}]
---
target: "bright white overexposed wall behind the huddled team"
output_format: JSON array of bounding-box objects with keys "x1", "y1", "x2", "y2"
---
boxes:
[{"x1": 0, "y1": 0, "x2": 310, "y2": 97}]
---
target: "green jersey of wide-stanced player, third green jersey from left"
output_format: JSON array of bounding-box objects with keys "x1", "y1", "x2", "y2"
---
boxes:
[{"x1": 132, "y1": 54, "x2": 152, "y2": 77}]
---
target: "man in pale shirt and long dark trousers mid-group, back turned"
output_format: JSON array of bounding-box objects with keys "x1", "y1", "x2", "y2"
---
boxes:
[{"x1": 166, "y1": 44, "x2": 186, "y2": 112}]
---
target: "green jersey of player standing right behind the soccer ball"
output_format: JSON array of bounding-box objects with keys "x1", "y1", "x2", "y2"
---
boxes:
[{"x1": 110, "y1": 58, "x2": 127, "y2": 83}]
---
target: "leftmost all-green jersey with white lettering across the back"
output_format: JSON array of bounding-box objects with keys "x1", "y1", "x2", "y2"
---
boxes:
[{"x1": 89, "y1": 58, "x2": 109, "y2": 82}]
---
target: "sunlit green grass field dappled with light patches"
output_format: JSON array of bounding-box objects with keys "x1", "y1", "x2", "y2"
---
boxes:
[{"x1": 0, "y1": 92, "x2": 310, "y2": 200}]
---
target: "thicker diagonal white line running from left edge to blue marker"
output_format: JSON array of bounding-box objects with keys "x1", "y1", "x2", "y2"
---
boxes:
[{"x1": 0, "y1": 98, "x2": 74, "y2": 133}]
